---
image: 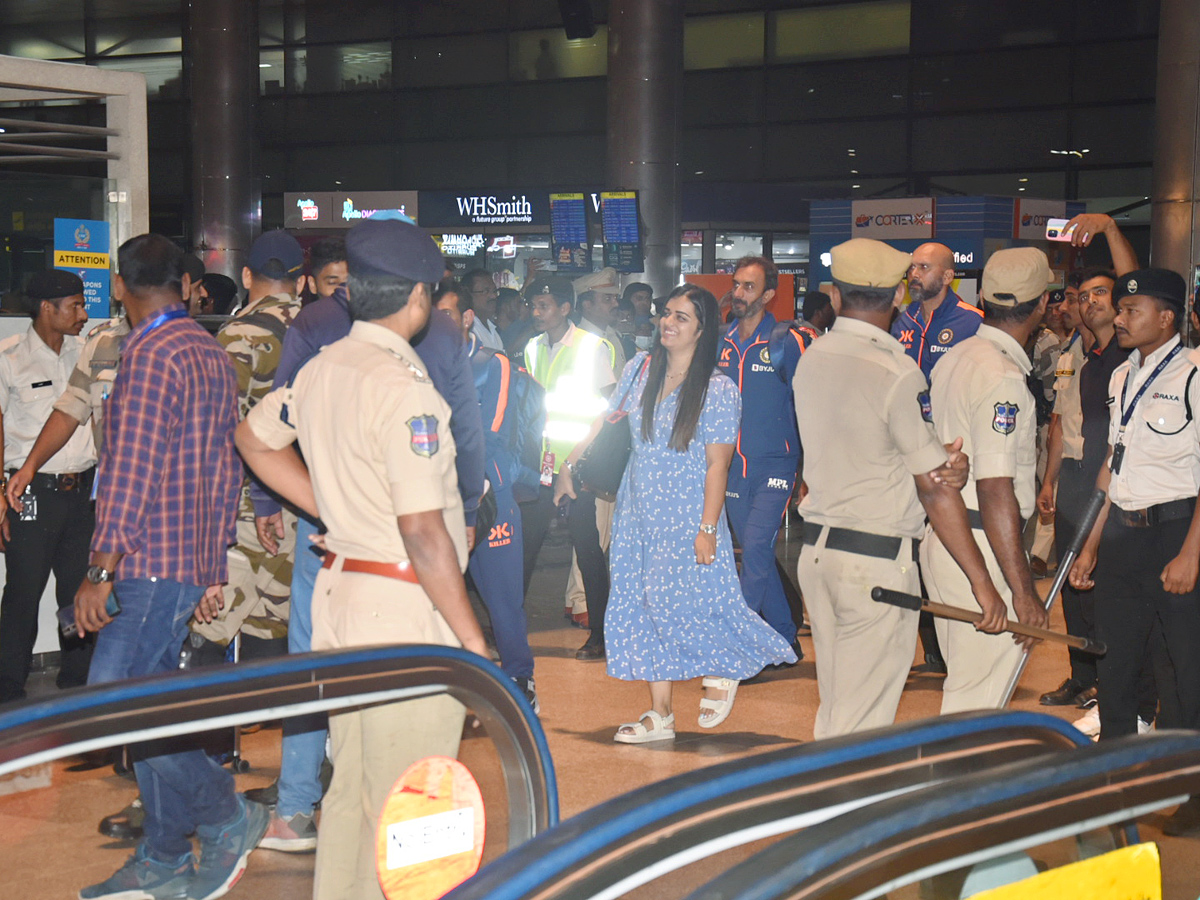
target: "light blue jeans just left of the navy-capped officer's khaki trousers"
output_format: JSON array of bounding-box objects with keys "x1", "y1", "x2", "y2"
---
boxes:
[{"x1": 275, "y1": 516, "x2": 326, "y2": 818}]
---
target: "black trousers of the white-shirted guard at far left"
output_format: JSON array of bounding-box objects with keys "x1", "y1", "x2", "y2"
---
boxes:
[{"x1": 0, "y1": 478, "x2": 96, "y2": 703}]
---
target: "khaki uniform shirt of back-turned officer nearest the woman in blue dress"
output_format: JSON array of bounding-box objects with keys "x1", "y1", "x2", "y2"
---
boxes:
[{"x1": 792, "y1": 316, "x2": 947, "y2": 538}]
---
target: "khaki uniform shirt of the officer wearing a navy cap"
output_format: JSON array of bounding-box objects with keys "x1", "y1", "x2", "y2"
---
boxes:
[{"x1": 246, "y1": 322, "x2": 467, "y2": 568}]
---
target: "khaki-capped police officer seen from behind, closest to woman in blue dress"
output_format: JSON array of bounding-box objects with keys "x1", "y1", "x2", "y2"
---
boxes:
[{"x1": 792, "y1": 239, "x2": 1006, "y2": 738}]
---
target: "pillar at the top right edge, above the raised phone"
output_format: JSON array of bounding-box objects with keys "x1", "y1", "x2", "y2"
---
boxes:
[{"x1": 1151, "y1": 0, "x2": 1200, "y2": 283}]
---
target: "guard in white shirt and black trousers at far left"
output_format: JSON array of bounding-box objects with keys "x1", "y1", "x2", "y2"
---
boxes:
[{"x1": 0, "y1": 269, "x2": 96, "y2": 703}]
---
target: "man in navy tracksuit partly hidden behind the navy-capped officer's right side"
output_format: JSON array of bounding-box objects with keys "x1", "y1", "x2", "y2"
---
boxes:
[{"x1": 433, "y1": 283, "x2": 539, "y2": 713}]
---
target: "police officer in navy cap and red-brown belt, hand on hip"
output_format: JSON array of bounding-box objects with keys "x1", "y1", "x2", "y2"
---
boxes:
[{"x1": 238, "y1": 220, "x2": 487, "y2": 900}]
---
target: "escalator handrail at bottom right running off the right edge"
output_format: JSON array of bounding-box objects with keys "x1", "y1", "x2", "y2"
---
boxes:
[{"x1": 688, "y1": 731, "x2": 1200, "y2": 900}]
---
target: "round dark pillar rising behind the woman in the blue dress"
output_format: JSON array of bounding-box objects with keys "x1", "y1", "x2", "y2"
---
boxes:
[{"x1": 605, "y1": 0, "x2": 683, "y2": 296}]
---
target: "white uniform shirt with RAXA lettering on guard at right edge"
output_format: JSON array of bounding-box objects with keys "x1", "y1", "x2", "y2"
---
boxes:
[{"x1": 1109, "y1": 335, "x2": 1200, "y2": 510}]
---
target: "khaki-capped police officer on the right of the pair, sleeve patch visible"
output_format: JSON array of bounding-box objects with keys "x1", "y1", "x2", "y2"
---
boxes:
[{"x1": 920, "y1": 247, "x2": 1050, "y2": 714}]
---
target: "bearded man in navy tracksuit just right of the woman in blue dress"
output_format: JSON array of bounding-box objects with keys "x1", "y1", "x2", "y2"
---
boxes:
[{"x1": 716, "y1": 257, "x2": 805, "y2": 656}]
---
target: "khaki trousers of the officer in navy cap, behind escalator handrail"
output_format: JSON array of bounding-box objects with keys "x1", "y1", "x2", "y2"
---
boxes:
[{"x1": 312, "y1": 562, "x2": 464, "y2": 900}]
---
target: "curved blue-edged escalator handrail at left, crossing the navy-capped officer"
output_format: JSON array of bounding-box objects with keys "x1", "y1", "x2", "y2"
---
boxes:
[{"x1": 0, "y1": 644, "x2": 558, "y2": 847}]
